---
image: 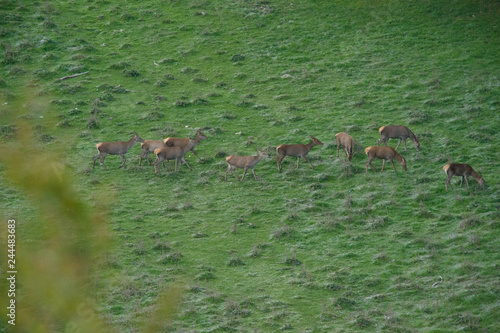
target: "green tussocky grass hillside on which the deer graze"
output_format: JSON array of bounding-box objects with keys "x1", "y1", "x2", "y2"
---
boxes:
[{"x1": 0, "y1": 0, "x2": 500, "y2": 332}]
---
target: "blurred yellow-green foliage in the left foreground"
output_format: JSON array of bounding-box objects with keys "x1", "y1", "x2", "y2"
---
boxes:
[{"x1": 0, "y1": 94, "x2": 180, "y2": 332}]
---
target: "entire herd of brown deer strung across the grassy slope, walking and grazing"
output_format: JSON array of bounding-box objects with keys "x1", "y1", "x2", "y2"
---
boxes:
[{"x1": 92, "y1": 125, "x2": 484, "y2": 191}]
